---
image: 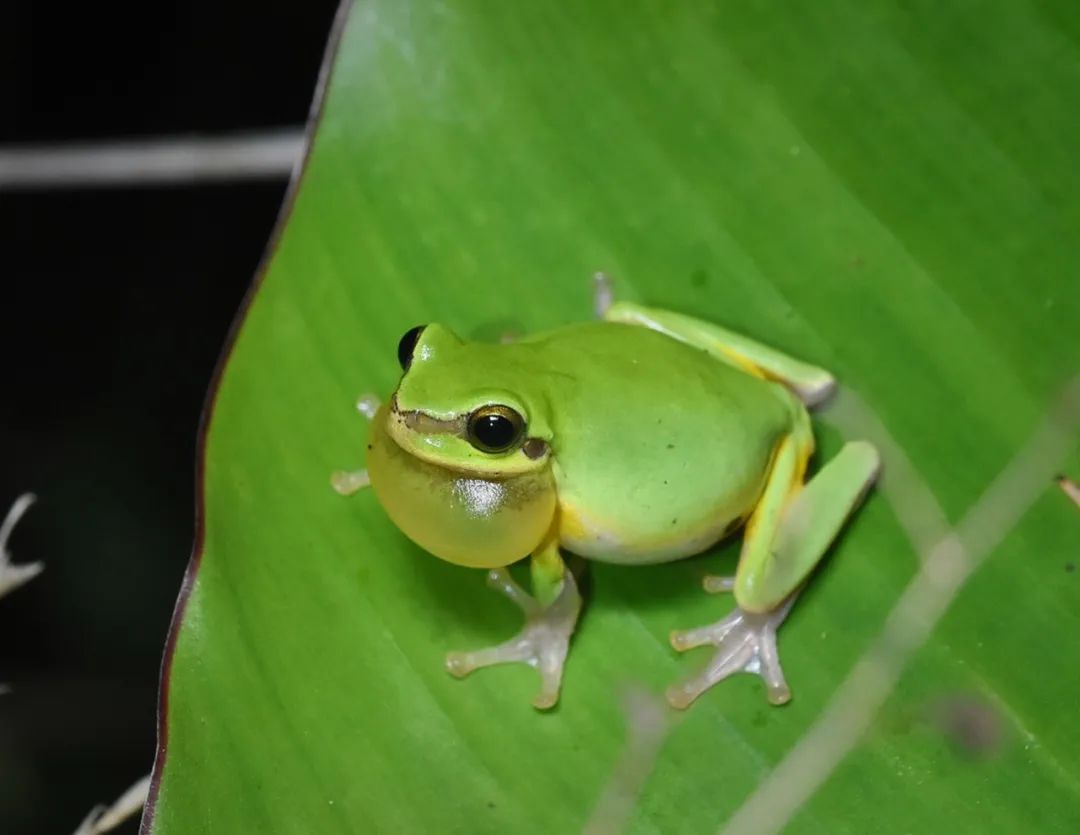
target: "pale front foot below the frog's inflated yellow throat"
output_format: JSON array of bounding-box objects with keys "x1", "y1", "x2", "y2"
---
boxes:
[{"x1": 446, "y1": 568, "x2": 581, "y2": 710}]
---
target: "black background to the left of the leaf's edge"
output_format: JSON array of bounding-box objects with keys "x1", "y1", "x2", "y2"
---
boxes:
[{"x1": 0, "y1": 0, "x2": 336, "y2": 835}]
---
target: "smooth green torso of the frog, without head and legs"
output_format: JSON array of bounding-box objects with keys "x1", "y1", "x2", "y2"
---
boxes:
[{"x1": 519, "y1": 322, "x2": 802, "y2": 563}]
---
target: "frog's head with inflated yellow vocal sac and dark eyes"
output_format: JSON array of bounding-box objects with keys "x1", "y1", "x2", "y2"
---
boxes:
[{"x1": 367, "y1": 325, "x2": 555, "y2": 567}]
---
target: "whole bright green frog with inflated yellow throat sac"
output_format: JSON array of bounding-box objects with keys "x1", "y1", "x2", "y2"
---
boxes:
[{"x1": 332, "y1": 273, "x2": 881, "y2": 710}]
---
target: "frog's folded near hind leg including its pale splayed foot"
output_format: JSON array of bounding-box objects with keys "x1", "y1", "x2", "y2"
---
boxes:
[{"x1": 667, "y1": 425, "x2": 880, "y2": 709}]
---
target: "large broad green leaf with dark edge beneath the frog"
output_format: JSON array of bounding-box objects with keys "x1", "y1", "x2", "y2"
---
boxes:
[{"x1": 147, "y1": 0, "x2": 1080, "y2": 835}]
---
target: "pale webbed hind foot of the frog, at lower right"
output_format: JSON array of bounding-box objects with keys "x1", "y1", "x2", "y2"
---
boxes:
[{"x1": 667, "y1": 588, "x2": 798, "y2": 710}]
